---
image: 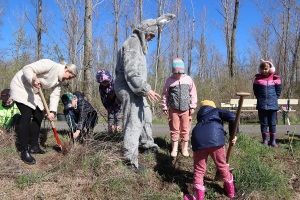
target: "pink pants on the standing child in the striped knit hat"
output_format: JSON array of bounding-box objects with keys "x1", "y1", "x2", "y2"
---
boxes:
[{"x1": 169, "y1": 108, "x2": 192, "y2": 141}]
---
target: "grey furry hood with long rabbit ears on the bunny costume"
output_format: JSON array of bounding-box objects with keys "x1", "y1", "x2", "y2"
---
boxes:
[{"x1": 135, "y1": 14, "x2": 176, "y2": 35}]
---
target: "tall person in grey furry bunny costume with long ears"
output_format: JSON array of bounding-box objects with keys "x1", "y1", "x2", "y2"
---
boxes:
[{"x1": 115, "y1": 14, "x2": 175, "y2": 172}]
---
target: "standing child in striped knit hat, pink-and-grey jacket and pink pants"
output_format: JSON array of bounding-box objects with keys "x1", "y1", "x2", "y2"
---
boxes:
[{"x1": 162, "y1": 58, "x2": 197, "y2": 158}]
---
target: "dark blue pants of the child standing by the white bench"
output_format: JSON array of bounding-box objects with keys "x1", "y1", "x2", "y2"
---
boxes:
[{"x1": 258, "y1": 110, "x2": 277, "y2": 133}]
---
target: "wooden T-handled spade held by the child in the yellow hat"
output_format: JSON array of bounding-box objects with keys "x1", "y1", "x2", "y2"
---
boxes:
[{"x1": 215, "y1": 92, "x2": 250, "y2": 180}]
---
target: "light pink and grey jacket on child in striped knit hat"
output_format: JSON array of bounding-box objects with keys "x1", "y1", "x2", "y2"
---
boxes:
[{"x1": 162, "y1": 74, "x2": 197, "y2": 111}]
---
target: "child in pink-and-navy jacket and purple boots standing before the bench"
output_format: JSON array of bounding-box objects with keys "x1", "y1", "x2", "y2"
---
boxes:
[{"x1": 253, "y1": 59, "x2": 282, "y2": 148}]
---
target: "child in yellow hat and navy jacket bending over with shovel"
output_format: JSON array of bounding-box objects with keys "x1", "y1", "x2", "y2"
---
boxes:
[{"x1": 184, "y1": 100, "x2": 236, "y2": 200}]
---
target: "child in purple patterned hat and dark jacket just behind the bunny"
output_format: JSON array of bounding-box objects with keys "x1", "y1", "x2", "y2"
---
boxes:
[{"x1": 96, "y1": 70, "x2": 122, "y2": 133}]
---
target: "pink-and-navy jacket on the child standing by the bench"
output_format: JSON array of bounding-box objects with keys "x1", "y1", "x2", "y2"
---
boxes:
[{"x1": 253, "y1": 73, "x2": 282, "y2": 110}]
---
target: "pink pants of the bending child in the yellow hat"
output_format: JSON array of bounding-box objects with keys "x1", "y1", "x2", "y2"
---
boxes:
[{"x1": 194, "y1": 146, "x2": 231, "y2": 186}]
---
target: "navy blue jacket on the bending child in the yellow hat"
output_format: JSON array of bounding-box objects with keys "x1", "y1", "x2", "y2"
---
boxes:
[{"x1": 191, "y1": 106, "x2": 235, "y2": 151}]
